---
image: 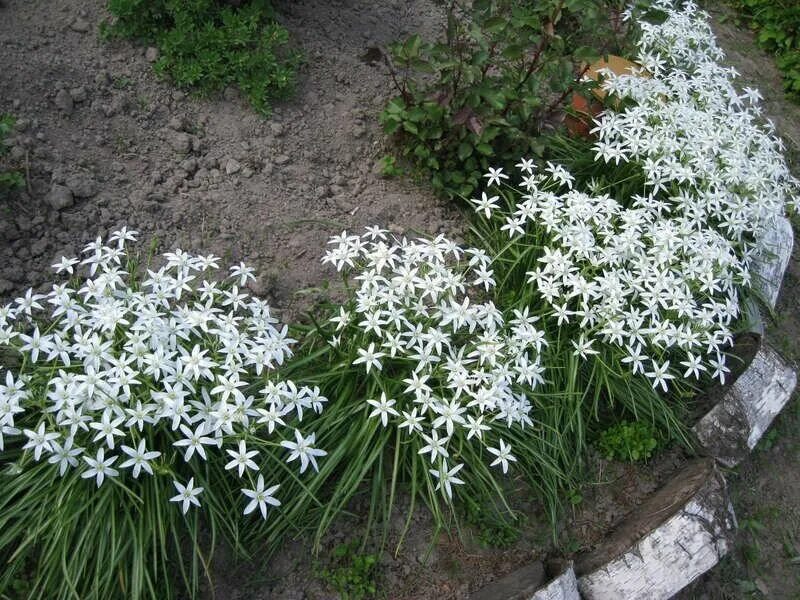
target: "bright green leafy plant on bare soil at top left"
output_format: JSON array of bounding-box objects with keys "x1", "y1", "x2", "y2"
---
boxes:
[{"x1": 105, "y1": 0, "x2": 300, "y2": 114}]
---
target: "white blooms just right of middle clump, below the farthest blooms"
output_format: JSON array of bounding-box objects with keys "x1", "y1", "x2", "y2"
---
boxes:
[{"x1": 475, "y1": 172, "x2": 736, "y2": 391}]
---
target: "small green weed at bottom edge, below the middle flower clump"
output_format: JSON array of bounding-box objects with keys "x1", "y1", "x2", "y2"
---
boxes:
[{"x1": 318, "y1": 541, "x2": 378, "y2": 600}]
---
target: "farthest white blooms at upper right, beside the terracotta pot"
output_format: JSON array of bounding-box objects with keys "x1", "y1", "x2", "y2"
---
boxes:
[{"x1": 594, "y1": 0, "x2": 800, "y2": 244}]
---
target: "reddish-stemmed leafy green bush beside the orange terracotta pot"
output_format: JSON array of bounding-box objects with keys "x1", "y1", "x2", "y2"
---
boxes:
[{"x1": 381, "y1": 0, "x2": 628, "y2": 197}]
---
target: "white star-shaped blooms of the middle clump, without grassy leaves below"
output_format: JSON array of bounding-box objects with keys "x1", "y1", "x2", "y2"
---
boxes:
[{"x1": 323, "y1": 227, "x2": 547, "y2": 498}]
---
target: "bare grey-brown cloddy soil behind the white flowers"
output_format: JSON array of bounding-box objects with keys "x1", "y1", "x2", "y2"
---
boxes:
[{"x1": 0, "y1": 0, "x2": 462, "y2": 316}]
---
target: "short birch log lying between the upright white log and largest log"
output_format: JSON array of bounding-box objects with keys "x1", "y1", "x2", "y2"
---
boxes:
[{"x1": 694, "y1": 344, "x2": 797, "y2": 467}]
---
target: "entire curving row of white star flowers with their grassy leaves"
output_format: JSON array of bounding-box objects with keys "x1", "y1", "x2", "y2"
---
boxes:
[{"x1": 0, "y1": 1, "x2": 798, "y2": 597}]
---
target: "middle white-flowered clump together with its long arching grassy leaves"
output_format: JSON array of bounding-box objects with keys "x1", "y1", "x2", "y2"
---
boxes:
[{"x1": 289, "y1": 227, "x2": 580, "y2": 542}]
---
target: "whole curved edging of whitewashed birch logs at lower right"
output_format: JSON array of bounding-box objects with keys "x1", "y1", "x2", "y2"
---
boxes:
[{"x1": 471, "y1": 217, "x2": 797, "y2": 600}]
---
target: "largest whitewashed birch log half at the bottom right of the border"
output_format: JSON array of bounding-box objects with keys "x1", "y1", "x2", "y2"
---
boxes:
[{"x1": 576, "y1": 460, "x2": 736, "y2": 600}]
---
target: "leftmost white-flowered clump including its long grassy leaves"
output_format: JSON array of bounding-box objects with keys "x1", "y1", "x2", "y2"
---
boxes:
[{"x1": 0, "y1": 228, "x2": 326, "y2": 598}]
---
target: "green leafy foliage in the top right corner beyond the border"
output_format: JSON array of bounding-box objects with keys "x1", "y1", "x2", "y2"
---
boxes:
[{"x1": 730, "y1": 0, "x2": 800, "y2": 102}]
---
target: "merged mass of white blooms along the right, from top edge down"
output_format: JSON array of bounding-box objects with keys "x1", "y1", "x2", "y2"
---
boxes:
[{"x1": 471, "y1": 0, "x2": 799, "y2": 391}]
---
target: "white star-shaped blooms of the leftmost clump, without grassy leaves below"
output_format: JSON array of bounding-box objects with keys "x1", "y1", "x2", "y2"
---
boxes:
[{"x1": 0, "y1": 228, "x2": 326, "y2": 518}]
